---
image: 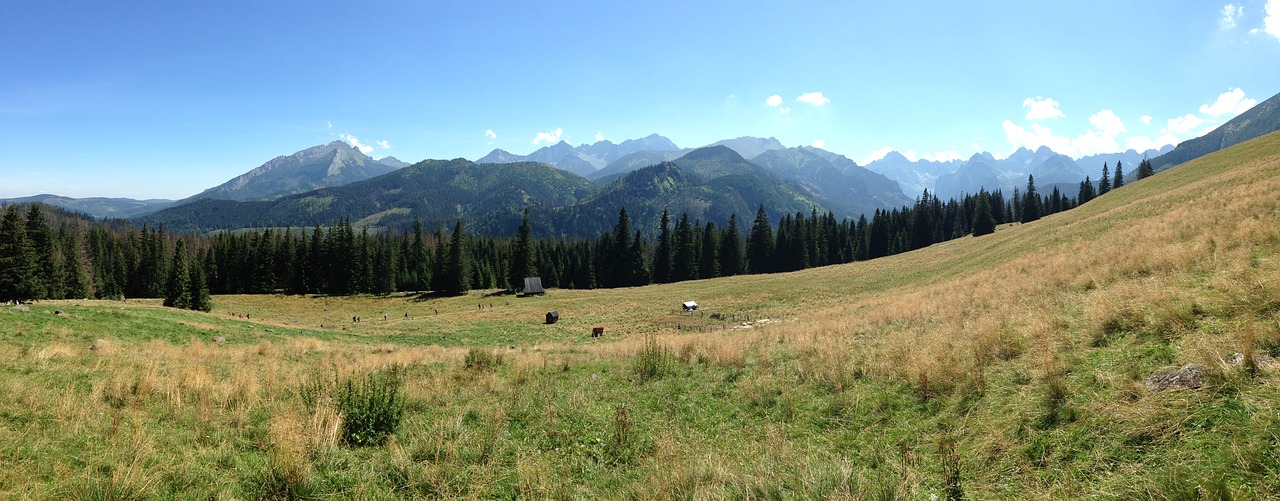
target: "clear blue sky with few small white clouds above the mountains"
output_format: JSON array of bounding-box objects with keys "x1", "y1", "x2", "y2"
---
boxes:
[{"x1": 0, "y1": 0, "x2": 1280, "y2": 199}]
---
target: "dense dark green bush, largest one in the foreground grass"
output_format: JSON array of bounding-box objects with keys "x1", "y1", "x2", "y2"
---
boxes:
[{"x1": 335, "y1": 366, "x2": 404, "y2": 447}]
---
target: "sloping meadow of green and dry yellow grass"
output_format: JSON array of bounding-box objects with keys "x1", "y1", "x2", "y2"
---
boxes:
[{"x1": 0, "y1": 135, "x2": 1280, "y2": 498}]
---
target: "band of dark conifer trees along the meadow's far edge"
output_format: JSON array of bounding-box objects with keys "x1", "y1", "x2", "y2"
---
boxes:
[{"x1": 0, "y1": 160, "x2": 1152, "y2": 306}]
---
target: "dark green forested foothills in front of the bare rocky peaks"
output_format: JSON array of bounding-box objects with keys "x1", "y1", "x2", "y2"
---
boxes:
[{"x1": 146, "y1": 146, "x2": 839, "y2": 237}]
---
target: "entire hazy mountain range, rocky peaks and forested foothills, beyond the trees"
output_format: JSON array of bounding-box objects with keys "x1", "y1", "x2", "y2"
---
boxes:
[{"x1": 6, "y1": 88, "x2": 1280, "y2": 225}]
